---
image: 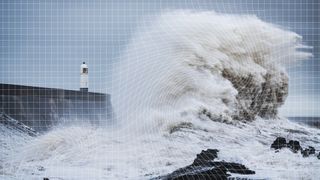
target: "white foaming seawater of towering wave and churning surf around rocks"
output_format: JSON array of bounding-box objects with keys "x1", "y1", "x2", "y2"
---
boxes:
[{"x1": 1, "y1": 11, "x2": 320, "y2": 179}]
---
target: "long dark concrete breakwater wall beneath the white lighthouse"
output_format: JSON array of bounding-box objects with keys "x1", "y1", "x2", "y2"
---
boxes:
[{"x1": 0, "y1": 84, "x2": 112, "y2": 131}]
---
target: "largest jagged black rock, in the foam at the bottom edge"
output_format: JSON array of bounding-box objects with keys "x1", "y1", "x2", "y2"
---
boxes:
[{"x1": 155, "y1": 149, "x2": 255, "y2": 180}]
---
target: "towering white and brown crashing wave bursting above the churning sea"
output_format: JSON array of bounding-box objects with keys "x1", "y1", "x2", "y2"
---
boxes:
[{"x1": 113, "y1": 11, "x2": 311, "y2": 129}]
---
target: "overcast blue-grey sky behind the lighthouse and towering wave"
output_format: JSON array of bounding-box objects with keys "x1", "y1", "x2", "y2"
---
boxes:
[{"x1": 0, "y1": 0, "x2": 320, "y2": 116}]
